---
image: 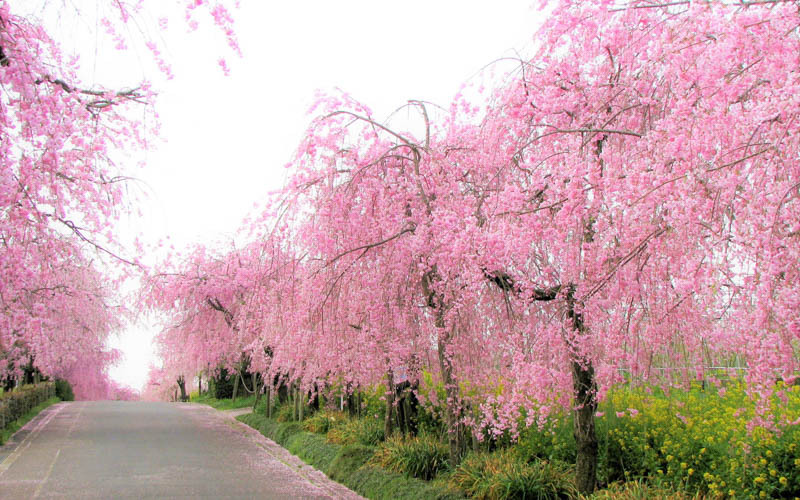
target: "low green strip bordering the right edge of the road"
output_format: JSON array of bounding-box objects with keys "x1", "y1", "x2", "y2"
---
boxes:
[{"x1": 237, "y1": 413, "x2": 463, "y2": 500}]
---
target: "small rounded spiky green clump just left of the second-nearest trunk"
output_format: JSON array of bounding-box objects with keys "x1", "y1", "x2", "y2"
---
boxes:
[{"x1": 372, "y1": 434, "x2": 449, "y2": 481}]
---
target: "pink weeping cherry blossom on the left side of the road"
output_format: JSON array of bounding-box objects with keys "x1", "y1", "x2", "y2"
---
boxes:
[{"x1": 0, "y1": 1, "x2": 238, "y2": 397}]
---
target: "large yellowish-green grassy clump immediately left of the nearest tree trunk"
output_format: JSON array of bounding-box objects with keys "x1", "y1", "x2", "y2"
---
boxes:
[{"x1": 451, "y1": 450, "x2": 578, "y2": 500}]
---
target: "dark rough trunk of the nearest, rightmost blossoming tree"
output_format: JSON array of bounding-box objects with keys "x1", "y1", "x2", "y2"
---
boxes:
[{"x1": 567, "y1": 286, "x2": 598, "y2": 495}]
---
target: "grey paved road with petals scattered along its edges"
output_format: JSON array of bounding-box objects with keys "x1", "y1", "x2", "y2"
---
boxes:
[{"x1": 0, "y1": 401, "x2": 361, "y2": 499}]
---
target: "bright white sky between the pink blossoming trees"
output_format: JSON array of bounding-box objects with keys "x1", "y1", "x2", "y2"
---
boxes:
[{"x1": 36, "y1": 0, "x2": 540, "y2": 389}]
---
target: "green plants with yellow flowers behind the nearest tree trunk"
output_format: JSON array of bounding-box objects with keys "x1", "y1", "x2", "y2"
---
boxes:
[{"x1": 512, "y1": 380, "x2": 800, "y2": 498}]
